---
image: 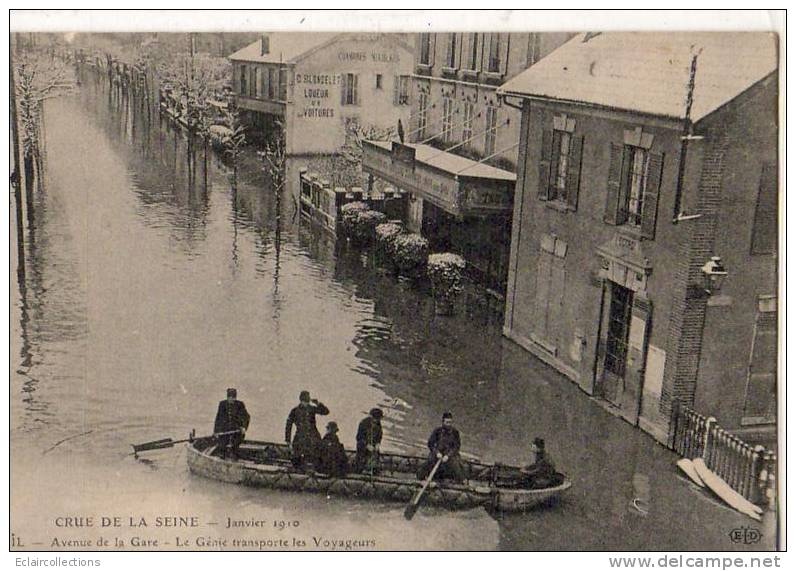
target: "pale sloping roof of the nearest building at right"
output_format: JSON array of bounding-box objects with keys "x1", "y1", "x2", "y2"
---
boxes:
[{"x1": 499, "y1": 32, "x2": 778, "y2": 122}]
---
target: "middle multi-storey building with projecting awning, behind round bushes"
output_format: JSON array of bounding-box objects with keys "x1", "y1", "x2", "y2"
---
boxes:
[{"x1": 364, "y1": 33, "x2": 572, "y2": 294}]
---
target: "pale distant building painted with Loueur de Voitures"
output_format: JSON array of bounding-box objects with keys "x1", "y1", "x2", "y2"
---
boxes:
[{"x1": 229, "y1": 33, "x2": 414, "y2": 155}]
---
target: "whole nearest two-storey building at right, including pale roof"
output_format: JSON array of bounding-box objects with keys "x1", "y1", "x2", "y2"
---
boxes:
[{"x1": 501, "y1": 33, "x2": 778, "y2": 441}]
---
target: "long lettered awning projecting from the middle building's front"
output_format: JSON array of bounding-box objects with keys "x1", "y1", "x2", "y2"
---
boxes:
[{"x1": 362, "y1": 141, "x2": 517, "y2": 218}]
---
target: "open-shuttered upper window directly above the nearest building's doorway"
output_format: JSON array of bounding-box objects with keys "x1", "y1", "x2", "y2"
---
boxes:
[{"x1": 603, "y1": 141, "x2": 663, "y2": 240}]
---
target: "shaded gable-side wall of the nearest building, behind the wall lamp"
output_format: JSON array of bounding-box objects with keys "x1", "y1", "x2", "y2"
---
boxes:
[{"x1": 695, "y1": 77, "x2": 778, "y2": 430}]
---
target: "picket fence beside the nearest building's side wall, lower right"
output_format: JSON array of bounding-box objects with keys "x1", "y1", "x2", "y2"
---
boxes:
[{"x1": 670, "y1": 403, "x2": 777, "y2": 504}]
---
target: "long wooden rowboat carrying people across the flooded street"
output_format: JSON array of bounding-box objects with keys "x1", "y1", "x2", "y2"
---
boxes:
[{"x1": 188, "y1": 438, "x2": 572, "y2": 512}]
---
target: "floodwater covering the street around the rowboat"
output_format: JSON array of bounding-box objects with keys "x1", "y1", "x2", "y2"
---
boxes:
[{"x1": 10, "y1": 69, "x2": 775, "y2": 550}]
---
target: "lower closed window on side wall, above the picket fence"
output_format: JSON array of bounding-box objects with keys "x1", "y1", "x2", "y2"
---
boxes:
[{"x1": 741, "y1": 295, "x2": 777, "y2": 425}]
